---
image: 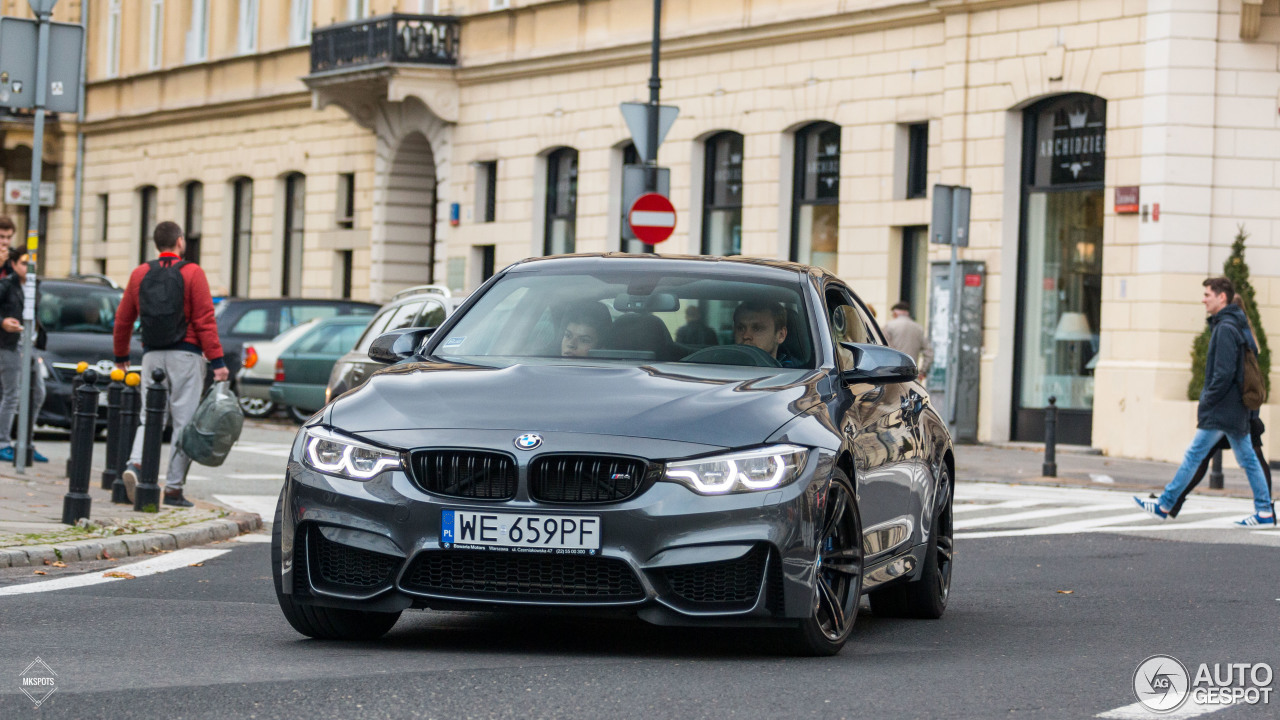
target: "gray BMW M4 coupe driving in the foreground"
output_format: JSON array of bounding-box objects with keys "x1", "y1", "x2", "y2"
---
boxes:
[{"x1": 271, "y1": 255, "x2": 955, "y2": 655}]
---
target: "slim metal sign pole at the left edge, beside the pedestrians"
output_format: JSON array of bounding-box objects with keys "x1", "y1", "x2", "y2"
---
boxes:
[{"x1": 15, "y1": 0, "x2": 58, "y2": 474}]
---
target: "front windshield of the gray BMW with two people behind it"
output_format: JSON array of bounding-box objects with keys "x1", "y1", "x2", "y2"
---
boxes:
[{"x1": 434, "y1": 268, "x2": 814, "y2": 368}]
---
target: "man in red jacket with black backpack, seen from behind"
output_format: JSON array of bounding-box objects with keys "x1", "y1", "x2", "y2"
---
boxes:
[{"x1": 114, "y1": 220, "x2": 229, "y2": 507}]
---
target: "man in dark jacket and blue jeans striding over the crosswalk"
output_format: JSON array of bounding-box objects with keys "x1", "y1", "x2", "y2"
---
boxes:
[{"x1": 1134, "y1": 278, "x2": 1276, "y2": 528}]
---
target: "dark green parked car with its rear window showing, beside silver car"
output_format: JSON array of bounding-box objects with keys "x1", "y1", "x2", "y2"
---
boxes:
[{"x1": 271, "y1": 315, "x2": 369, "y2": 423}]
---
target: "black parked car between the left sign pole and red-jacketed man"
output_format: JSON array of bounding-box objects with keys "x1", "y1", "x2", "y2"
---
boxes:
[{"x1": 37, "y1": 278, "x2": 142, "y2": 428}]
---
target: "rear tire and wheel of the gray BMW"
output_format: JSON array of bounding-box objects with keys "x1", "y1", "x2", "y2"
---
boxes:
[{"x1": 868, "y1": 466, "x2": 955, "y2": 620}]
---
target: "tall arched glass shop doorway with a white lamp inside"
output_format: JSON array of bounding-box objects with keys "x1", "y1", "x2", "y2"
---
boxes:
[{"x1": 1012, "y1": 94, "x2": 1106, "y2": 445}]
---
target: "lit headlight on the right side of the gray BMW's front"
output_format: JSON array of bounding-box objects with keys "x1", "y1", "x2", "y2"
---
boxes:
[{"x1": 663, "y1": 445, "x2": 809, "y2": 495}]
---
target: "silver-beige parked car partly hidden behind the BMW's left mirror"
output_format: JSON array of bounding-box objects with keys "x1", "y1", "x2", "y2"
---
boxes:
[{"x1": 326, "y1": 284, "x2": 463, "y2": 401}]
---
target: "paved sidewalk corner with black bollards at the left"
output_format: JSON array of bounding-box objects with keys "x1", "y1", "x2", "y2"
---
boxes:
[{"x1": 0, "y1": 454, "x2": 262, "y2": 568}]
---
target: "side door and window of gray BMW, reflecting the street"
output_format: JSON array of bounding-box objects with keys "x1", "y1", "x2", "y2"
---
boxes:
[{"x1": 824, "y1": 283, "x2": 919, "y2": 556}]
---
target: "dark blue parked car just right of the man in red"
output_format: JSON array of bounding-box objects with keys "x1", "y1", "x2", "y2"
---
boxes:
[{"x1": 214, "y1": 297, "x2": 378, "y2": 416}]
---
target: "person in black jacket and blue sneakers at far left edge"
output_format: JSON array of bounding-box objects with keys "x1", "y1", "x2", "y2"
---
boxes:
[{"x1": 0, "y1": 244, "x2": 49, "y2": 462}]
